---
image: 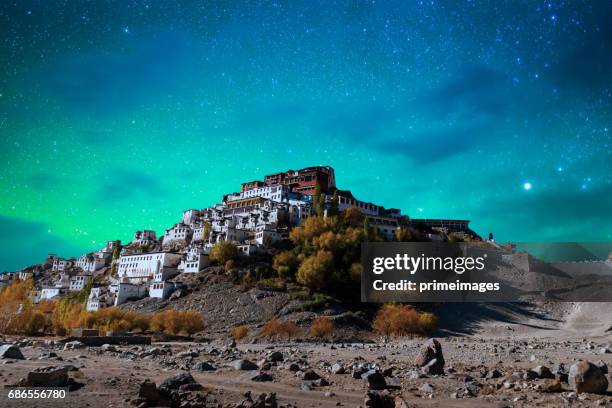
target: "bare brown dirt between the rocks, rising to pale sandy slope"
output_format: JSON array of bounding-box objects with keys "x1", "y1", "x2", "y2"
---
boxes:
[{"x1": 0, "y1": 304, "x2": 612, "y2": 408}]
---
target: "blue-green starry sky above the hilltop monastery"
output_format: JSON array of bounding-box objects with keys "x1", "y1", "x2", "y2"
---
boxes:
[{"x1": 0, "y1": 0, "x2": 612, "y2": 271}]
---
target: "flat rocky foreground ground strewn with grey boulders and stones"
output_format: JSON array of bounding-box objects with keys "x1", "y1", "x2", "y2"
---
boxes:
[{"x1": 0, "y1": 323, "x2": 612, "y2": 408}]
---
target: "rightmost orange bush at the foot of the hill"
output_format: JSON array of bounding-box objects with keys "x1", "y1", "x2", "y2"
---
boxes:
[{"x1": 373, "y1": 304, "x2": 438, "y2": 336}]
